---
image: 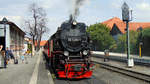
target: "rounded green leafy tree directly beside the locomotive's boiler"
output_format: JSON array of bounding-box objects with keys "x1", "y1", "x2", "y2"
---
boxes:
[{"x1": 87, "y1": 23, "x2": 115, "y2": 51}]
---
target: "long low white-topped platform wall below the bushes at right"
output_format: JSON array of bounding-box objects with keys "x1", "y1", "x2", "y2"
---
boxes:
[{"x1": 92, "y1": 51, "x2": 150, "y2": 66}]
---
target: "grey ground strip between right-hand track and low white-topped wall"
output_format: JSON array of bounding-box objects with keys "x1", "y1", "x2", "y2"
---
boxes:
[{"x1": 92, "y1": 57, "x2": 150, "y2": 76}]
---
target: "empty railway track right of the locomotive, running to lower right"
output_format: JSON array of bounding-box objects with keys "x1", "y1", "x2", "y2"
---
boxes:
[{"x1": 93, "y1": 61, "x2": 150, "y2": 83}]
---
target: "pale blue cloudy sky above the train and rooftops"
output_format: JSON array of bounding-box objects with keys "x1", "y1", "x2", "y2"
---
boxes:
[{"x1": 0, "y1": 0, "x2": 150, "y2": 40}]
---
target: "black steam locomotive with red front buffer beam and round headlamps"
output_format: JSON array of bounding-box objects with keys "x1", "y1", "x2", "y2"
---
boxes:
[{"x1": 44, "y1": 20, "x2": 92, "y2": 79}]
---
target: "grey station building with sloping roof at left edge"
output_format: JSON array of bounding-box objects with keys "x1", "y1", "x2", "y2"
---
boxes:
[{"x1": 0, "y1": 18, "x2": 25, "y2": 56}]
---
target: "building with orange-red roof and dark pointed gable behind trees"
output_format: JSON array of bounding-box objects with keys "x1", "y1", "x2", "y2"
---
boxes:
[{"x1": 102, "y1": 17, "x2": 150, "y2": 40}]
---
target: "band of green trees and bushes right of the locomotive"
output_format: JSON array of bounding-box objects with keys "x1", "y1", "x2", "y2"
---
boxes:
[{"x1": 87, "y1": 24, "x2": 150, "y2": 55}]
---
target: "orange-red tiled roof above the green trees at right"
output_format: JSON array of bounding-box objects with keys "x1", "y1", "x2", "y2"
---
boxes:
[{"x1": 102, "y1": 17, "x2": 150, "y2": 33}]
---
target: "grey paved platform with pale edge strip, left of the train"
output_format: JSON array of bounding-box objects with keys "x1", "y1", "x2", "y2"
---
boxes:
[{"x1": 0, "y1": 51, "x2": 54, "y2": 84}]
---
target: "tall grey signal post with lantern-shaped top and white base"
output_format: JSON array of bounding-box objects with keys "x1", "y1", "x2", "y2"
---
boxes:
[{"x1": 122, "y1": 2, "x2": 134, "y2": 67}]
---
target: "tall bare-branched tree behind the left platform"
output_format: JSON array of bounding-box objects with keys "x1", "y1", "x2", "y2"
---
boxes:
[{"x1": 25, "y1": 3, "x2": 48, "y2": 53}]
